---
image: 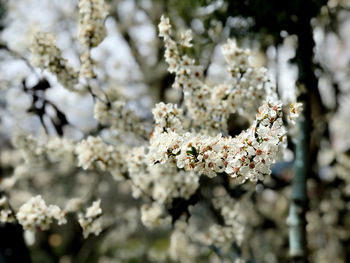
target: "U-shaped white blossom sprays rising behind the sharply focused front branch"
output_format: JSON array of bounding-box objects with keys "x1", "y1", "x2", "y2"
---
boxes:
[{"x1": 159, "y1": 16, "x2": 273, "y2": 134}]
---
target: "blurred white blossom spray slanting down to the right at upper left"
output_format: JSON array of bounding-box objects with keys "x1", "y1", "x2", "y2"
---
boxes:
[{"x1": 30, "y1": 32, "x2": 78, "y2": 90}]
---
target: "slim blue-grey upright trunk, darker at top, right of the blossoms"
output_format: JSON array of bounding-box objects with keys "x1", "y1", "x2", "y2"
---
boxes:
[{"x1": 287, "y1": 0, "x2": 318, "y2": 262}]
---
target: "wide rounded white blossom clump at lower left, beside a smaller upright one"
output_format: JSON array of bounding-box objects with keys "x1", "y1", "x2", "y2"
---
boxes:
[{"x1": 16, "y1": 195, "x2": 67, "y2": 231}]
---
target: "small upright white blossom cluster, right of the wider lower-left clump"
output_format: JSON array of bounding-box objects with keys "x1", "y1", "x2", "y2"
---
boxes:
[{"x1": 78, "y1": 200, "x2": 102, "y2": 238}]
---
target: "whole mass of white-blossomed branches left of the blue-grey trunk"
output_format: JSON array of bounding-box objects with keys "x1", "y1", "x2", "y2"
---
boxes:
[{"x1": 0, "y1": 0, "x2": 318, "y2": 262}]
